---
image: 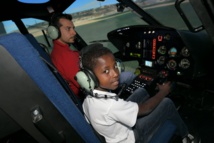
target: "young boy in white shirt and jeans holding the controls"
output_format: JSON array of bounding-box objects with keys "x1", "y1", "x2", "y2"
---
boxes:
[{"x1": 77, "y1": 44, "x2": 193, "y2": 143}]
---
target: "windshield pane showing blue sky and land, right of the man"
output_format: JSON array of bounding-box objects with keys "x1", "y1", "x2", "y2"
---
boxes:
[{"x1": 67, "y1": 0, "x2": 148, "y2": 52}]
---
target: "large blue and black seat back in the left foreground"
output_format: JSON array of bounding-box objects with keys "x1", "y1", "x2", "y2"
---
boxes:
[{"x1": 0, "y1": 33, "x2": 100, "y2": 143}]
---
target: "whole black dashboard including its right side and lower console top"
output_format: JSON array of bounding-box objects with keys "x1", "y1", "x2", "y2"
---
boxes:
[{"x1": 107, "y1": 25, "x2": 213, "y2": 94}]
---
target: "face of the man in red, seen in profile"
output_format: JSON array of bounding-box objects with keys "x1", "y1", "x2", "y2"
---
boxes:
[{"x1": 59, "y1": 18, "x2": 76, "y2": 44}]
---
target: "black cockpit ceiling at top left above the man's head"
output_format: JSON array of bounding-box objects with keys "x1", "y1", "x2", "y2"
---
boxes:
[{"x1": 0, "y1": 0, "x2": 74, "y2": 21}]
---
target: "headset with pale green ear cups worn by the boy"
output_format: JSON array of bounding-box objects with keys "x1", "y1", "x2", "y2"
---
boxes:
[{"x1": 75, "y1": 43, "x2": 123, "y2": 95}]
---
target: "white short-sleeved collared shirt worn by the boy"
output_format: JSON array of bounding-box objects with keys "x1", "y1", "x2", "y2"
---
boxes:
[{"x1": 83, "y1": 90, "x2": 139, "y2": 143}]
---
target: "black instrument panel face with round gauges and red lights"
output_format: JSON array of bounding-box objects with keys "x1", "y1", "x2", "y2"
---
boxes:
[{"x1": 107, "y1": 25, "x2": 194, "y2": 75}]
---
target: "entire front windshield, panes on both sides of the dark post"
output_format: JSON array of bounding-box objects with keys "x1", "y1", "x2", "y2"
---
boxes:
[{"x1": 65, "y1": 0, "x2": 201, "y2": 52}]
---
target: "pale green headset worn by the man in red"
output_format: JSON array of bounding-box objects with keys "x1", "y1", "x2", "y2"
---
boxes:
[{"x1": 47, "y1": 14, "x2": 62, "y2": 40}]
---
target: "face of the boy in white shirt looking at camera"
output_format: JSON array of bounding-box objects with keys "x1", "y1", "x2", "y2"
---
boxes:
[{"x1": 94, "y1": 54, "x2": 119, "y2": 90}]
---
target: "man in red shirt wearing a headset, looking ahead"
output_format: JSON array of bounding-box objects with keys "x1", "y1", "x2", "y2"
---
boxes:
[{"x1": 49, "y1": 14, "x2": 81, "y2": 98}]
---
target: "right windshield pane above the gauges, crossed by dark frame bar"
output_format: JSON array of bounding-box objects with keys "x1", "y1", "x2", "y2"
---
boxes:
[{"x1": 133, "y1": 0, "x2": 202, "y2": 30}]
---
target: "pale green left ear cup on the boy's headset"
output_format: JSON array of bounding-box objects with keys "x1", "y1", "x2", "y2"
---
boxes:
[{"x1": 75, "y1": 69, "x2": 97, "y2": 93}]
